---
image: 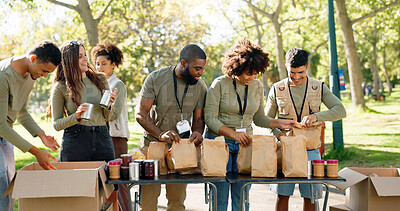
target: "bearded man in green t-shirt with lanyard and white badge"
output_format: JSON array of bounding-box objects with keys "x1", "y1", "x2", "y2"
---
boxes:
[{"x1": 136, "y1": 44, "x2": 207, "y2": 211}]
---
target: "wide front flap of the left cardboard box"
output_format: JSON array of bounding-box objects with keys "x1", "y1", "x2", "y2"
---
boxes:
[{"x1": 12, "y1": 169, "x2": 98, "y2": 198}]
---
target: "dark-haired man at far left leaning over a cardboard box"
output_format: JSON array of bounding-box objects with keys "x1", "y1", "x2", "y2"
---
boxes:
[{"x1": 0, "y1": 41, "x2": 61, "y2": 211}]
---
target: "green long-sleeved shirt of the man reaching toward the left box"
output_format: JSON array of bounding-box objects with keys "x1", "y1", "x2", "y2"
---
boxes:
[{"x1": 0, "y1": 58, "x2": 42, "y2": 152}]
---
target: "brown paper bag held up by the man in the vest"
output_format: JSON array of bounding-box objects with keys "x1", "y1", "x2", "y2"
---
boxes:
[{"x1": 293, "y1": 122, "x2": 322, "y2": 150}]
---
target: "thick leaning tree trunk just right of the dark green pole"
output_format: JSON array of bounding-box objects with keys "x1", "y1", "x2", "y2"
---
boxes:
[{"x1": 335, "y1": 0, "x2": 365, "y2": 109}]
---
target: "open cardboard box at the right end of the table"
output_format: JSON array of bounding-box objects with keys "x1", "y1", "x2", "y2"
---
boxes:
[{"x1": 328, "y1": 167, "x2": 400, "y2": 211}]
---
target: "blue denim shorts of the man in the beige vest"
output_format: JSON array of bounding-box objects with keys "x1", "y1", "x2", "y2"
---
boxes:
[{"x1": 269, "y1": 149, "x2": 322, "y2": 199}]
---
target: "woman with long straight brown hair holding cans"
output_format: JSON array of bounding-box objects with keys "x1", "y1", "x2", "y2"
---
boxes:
[{"x1": 50, "y1": 41, "x2": 116, "y2": 162}]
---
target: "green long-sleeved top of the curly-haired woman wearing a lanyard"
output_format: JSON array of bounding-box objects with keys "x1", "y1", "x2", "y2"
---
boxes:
[{"x1": 204, "y1": 75, "x2": 272, "y2": 139}]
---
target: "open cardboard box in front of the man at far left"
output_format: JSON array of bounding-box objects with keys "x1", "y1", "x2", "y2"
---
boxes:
[{"x1": 5, "y1": 162, "x2": 114, "y2": 211}]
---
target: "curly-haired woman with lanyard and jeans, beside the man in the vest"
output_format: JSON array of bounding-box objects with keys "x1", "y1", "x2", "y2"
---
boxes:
[{"x1": 204, "y1": 38, "x2": 295, "y2": 211}]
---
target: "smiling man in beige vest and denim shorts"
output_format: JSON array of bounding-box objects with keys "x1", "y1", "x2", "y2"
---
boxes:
[{"x1": 265, "y1": 48, "x2": 346, "y2": 210}]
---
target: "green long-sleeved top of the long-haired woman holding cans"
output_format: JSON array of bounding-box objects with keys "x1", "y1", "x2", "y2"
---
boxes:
[{"x1": 50, "y1": 75, "x2": 113, "y2": 131}]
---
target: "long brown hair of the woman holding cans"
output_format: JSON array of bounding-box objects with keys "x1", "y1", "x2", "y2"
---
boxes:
[{"x1": 53, "y1": 41, "x2": 106, "y2": 106}]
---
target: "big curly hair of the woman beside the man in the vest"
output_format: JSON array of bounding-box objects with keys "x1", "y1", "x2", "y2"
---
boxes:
[{"x1": 222, "y1": 38, "x2": 269, "y2": 76}]
